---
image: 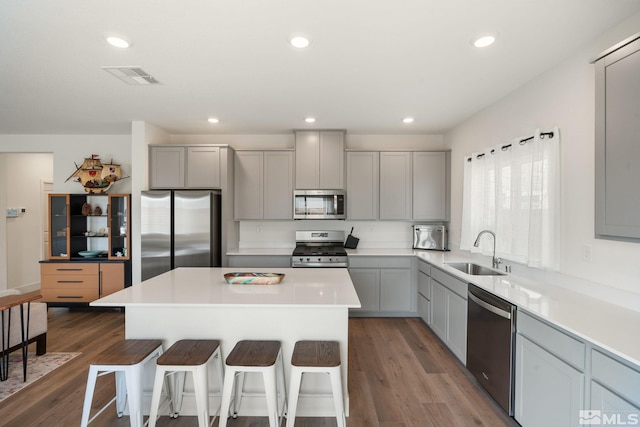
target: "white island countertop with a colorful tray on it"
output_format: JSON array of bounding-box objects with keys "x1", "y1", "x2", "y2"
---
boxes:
[{"x1": 91, "y1": 267, "x2": 360, "y2": 308}]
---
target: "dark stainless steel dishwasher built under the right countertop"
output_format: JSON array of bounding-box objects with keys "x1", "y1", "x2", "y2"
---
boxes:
[{"x1": 467, "y1": 284, "x2": 516, "y2": 415}]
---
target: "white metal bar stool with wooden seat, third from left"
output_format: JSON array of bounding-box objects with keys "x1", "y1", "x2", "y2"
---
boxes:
[{"x1": 219, "y1": 341, "x2": 287, "y2": 427}]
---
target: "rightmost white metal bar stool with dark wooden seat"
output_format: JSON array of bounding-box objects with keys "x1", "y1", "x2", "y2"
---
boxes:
[{"x1": 287, "y1": 341, "x2": 346, "y2": 427}]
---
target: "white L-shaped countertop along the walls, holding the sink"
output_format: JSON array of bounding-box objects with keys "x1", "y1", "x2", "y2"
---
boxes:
[{"x1": 228, "y1": 248, "x2": 640, "y2": 366}]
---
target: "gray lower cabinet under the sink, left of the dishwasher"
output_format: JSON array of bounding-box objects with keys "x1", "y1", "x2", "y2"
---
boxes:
[{"x1": 429, "y1": 268, "x2": 468, "y2": 364}]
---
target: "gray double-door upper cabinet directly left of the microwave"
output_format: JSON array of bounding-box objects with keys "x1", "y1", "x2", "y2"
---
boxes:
[{"x1": 234, "y1": 151, "x2": 293, "y2": 220}]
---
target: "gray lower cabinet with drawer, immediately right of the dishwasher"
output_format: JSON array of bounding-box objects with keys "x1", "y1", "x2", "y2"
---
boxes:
[{"x1": 514, "y1": 311, "x2": 586, "y2": 427}]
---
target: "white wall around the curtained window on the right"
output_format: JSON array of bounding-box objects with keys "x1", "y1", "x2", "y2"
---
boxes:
[{"x1": 445, "y1": 14, "x2": 640, "y2": 294}]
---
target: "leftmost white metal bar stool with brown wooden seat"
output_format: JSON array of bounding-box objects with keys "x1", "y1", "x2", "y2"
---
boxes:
[{"x1": 80, "y1": 339, "x2": 162, "y2": 427}]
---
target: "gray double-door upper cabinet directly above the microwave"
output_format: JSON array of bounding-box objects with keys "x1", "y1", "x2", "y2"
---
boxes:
[{"x1": 295, "y1": 130, "x2": 344, "y2": 190}]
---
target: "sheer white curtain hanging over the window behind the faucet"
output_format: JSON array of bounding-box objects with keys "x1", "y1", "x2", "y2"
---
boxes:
[{"x1": 460, "y1": 127, "x2": 560, "y2": 270}]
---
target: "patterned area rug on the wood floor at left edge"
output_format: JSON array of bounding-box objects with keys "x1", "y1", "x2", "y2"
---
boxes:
[{"x1": 0, "y1": 351, "x2": 82, "y2": 402}]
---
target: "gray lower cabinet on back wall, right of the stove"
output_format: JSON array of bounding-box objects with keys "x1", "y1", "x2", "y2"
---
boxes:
[{"x1": 349, "y1": 257, "x2": 416, "y2": 316}]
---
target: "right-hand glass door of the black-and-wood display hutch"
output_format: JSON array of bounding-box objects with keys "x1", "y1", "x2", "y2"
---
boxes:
[{"x1": 108, "y1": 194, "x2": 131, "y2": 260}]
